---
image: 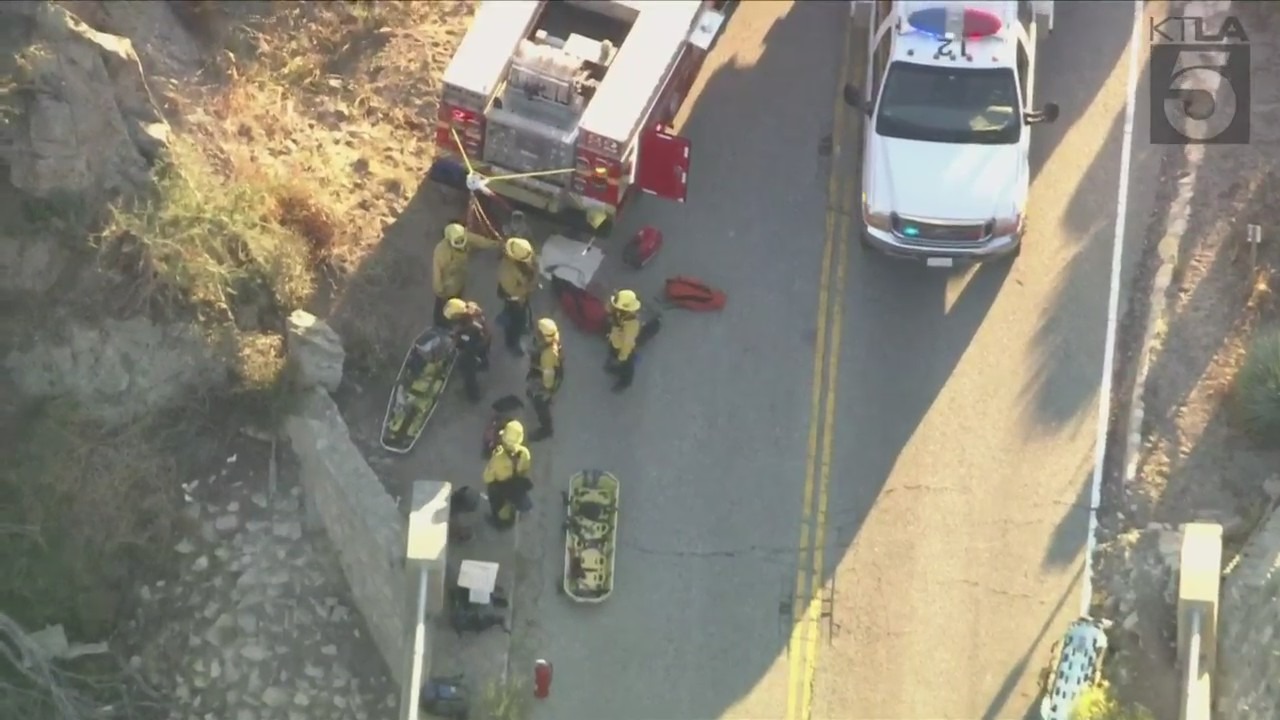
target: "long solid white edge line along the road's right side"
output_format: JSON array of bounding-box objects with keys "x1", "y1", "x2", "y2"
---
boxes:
[{"x1": 1080, "y1": 0, "x2": 1143, "y2": 615}]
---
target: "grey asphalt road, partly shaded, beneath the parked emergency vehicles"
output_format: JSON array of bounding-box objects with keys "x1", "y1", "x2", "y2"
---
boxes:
[{"x1": 516, "y1": 1, "x2": 1155, "y2": 720}]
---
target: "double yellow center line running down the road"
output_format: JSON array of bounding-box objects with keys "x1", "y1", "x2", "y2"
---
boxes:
[{"x1": 787, "y1": 11, "x2": 861, "y2": 720}]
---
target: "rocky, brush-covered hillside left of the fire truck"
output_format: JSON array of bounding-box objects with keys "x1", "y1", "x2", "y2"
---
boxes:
[{"x1": 0, "y1": 0, "x2": 471, "y2": 717}]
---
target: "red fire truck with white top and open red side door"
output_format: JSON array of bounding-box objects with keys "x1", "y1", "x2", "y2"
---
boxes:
[{"x1": 430, "y1": 0, "x2": 724, "y2": 234}]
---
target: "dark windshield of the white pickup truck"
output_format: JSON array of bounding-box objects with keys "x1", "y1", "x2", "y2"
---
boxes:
[{"x1": 876, "y1": 61, "x2": 1023, "y2": 145}]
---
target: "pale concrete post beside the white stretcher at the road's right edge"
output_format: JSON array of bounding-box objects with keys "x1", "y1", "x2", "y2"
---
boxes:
[{"x1": 1178, "y1": 523, "x2": 1222, "y2": 720}]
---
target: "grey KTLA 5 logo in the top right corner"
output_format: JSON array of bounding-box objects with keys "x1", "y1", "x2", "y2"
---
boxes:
[{"x1": 1149, "y1": 17, "x2": 1249, "y2": 145}]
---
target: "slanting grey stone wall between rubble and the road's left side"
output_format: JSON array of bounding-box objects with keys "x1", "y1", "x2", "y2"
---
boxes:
[{"x1": 284, "y1": 387, "x2": 412, "y2": 683}]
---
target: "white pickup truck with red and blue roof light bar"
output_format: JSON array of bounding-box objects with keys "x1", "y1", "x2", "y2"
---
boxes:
[{"x1": 845, "y1": 0, "x2": 1059, "y2": 268}]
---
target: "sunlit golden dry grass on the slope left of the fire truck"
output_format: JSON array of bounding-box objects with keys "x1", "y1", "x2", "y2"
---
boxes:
[{"x1": 192, "y1": 1, "x2": 474, "y2": 275}]
